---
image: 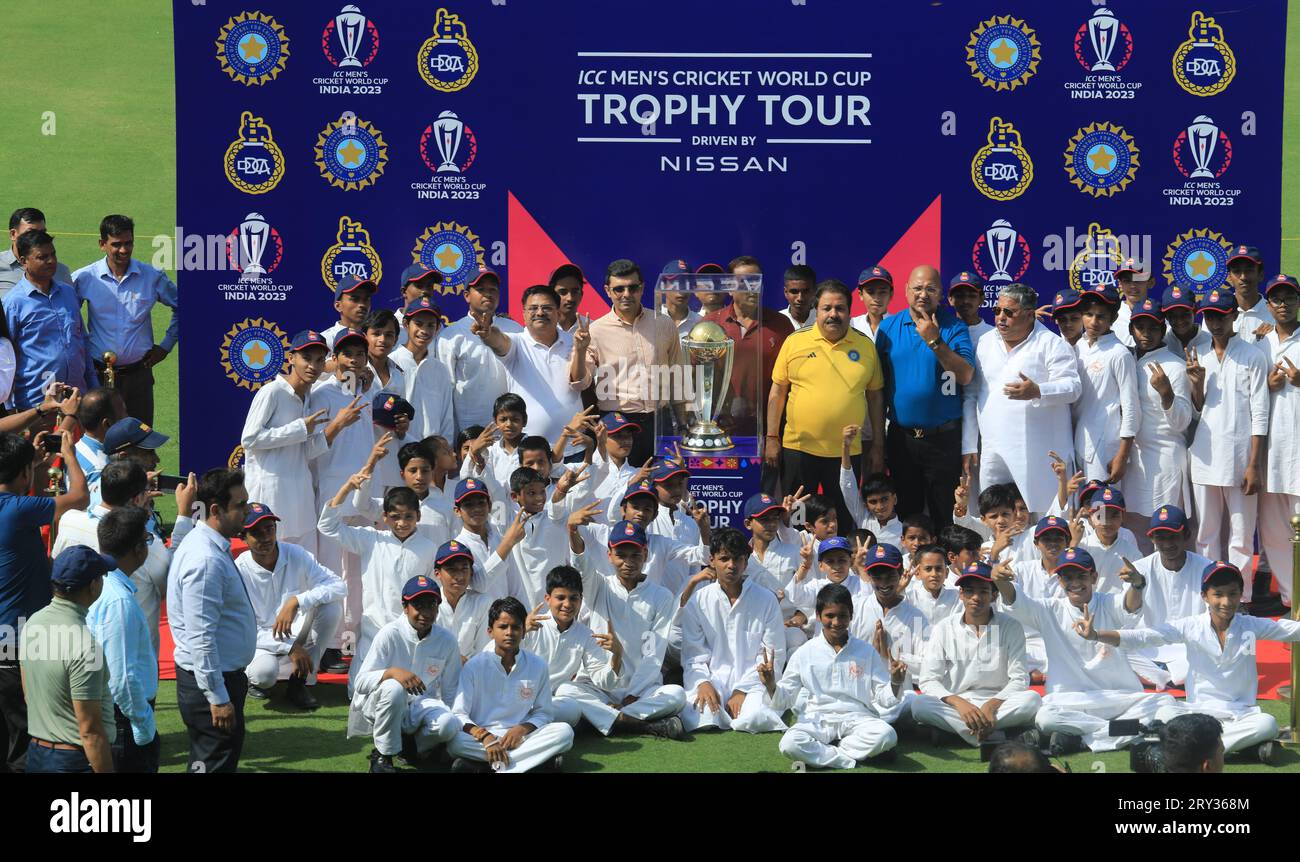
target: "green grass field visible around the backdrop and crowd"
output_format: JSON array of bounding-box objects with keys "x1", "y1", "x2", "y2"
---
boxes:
[{"x1": 0, "y1": 0, "x2": 1300, "y2": 772}]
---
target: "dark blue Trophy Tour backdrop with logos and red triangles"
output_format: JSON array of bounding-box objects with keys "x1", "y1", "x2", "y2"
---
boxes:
[{"x1": 174, "y1": 0, "x2": 1286, "y2": 478}]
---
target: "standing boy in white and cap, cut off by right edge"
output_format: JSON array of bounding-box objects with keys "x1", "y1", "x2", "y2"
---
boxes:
[{"x1": 1256, "y1": 276, "x2": 1300, "y2": 607}]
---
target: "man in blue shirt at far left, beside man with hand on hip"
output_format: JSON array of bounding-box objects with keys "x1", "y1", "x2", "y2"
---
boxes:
[{"x1": 4, "y1": 230, "x2": 99, "y2": 410}]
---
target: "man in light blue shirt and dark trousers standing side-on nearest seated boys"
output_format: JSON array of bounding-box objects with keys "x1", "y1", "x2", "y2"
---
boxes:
[{"x1": 166, "y1": 468, "x2": 257, "y2": 772}]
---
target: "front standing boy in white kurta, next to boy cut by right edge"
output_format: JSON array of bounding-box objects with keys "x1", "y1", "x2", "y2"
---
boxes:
[{"x1": 1188, "y1": 290, "x2": 1269, "y2": 602}]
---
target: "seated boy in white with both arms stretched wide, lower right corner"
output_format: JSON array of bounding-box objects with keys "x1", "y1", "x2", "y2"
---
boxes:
[{"x1": 1092, "y1": 562, "x2": 1300, "y2": 754}]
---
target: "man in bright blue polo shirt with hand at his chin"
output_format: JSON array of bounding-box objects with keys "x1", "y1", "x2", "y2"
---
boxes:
[{"x1": 876, "y1": 265, "x2": 975, "y2": 530}]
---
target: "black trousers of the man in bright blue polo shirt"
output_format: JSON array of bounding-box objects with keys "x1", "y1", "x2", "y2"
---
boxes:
[{"x1": 885, "y1": 421, "x2": 962, "y2": 540}]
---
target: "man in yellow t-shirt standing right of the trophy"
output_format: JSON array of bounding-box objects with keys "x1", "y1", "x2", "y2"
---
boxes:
[{"x1": 764, "y1": 278, "x2": 885, "y2": 532}]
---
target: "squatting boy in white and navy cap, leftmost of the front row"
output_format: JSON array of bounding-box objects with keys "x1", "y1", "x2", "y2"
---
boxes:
[{"x1": 347, "y1": 575, "x2": 462, "y2": 772}]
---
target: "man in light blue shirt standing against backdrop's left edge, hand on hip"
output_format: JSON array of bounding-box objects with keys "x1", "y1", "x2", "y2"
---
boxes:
[{"x1": 73, "y1": 216, "x2": 179, "y2": 425}]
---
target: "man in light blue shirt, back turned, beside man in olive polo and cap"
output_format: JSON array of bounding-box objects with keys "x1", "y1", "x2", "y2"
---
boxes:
[{"x1": 86, "y1": 506, "x2": 160, "y2": 772}]
